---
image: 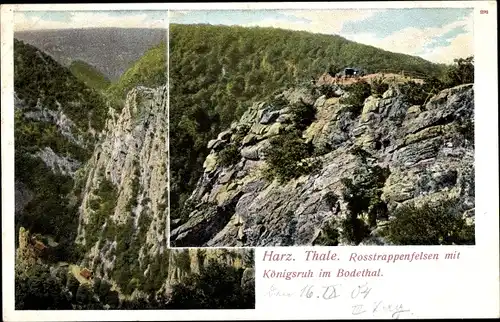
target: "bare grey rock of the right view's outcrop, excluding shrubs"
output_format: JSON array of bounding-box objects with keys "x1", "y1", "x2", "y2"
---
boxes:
[{"x1": 170, "y1": 84, "x2": 474, "y2": 247}]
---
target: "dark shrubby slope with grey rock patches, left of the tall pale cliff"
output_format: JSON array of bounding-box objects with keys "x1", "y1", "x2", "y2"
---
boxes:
[{"x1": 14, "y1": 39, "x2": 107, "y2": 252}]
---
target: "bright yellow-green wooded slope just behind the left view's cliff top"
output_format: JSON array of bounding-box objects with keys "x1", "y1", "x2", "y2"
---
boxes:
[{"x1": 107, "y1": 42, "x2": 167, "y2": 101}]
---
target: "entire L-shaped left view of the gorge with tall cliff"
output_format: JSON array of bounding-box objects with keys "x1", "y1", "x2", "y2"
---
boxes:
[{"x1": 11, "y1": 10, "x2": 255, "y2": 310}]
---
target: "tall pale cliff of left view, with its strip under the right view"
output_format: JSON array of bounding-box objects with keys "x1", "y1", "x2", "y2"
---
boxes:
[{"x1": 76, "y1": 86, "x2": 253, "y2": 296}]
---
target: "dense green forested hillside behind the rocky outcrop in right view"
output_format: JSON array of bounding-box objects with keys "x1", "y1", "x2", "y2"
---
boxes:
[{"x1": 169, "y1": 24, "x2": 444, "y2": 219}]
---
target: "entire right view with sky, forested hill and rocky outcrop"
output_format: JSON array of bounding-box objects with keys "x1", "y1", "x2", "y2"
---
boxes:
[{"x1": 168, "y1": 8, "x2": 475, "y2": 247}]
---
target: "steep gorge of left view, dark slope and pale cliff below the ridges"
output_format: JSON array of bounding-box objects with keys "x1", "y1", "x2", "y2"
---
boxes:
[{"x1": 15, "y1": 40, "x2": 253, "y2": 309}]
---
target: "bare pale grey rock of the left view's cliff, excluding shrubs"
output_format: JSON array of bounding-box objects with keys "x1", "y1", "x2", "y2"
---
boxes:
[{"x1": 77, "y1": 86, "x2": 168, "y2": 260}]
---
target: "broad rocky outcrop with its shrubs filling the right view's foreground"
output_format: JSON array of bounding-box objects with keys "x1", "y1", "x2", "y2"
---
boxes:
[{"x1": 170, "y1": 83, "x2": 474, "y2": 247}]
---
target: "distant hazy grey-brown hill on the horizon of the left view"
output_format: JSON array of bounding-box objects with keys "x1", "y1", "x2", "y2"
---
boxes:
[{"x1": 14, "y1": 28, "x2": 167, "y2": 81}]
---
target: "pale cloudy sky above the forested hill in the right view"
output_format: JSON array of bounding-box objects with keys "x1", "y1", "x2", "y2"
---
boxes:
[{"x1": 169, "y1": 8, "x2": 474, "y2": 63}]
